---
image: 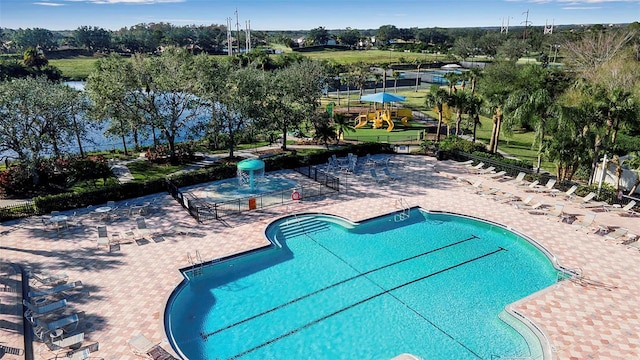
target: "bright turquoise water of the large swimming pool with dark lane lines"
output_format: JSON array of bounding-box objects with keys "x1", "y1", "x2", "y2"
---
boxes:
[{"x1": 165, "y1": 209, "x2": 558, "y2": 360}]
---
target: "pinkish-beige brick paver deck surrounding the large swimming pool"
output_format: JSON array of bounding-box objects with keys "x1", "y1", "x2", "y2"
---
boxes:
[{"x1": 0, "y1": 155, "x2": 640, "y2": 360}]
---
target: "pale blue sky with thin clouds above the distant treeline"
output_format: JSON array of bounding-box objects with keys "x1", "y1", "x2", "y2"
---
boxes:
[{"x1": 0, "y1": 0, "x2": 640, "y2": 31}]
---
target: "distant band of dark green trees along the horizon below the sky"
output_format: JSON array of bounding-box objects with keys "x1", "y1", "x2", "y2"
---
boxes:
[{"x1": 0, "y1": 22, "x2": 640, "y2": 59}]
